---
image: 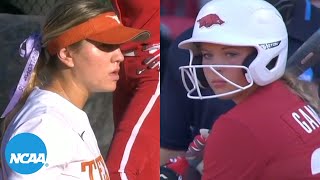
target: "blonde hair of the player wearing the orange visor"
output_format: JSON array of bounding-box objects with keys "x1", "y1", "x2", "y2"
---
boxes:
[{"x1": 0, "y1": 0, "x2": 113, "y2": 141}]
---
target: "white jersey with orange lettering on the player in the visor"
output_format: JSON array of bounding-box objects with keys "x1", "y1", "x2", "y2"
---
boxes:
[{"x1": 1, "y1": 87, "x2": 109, "y2": 180}]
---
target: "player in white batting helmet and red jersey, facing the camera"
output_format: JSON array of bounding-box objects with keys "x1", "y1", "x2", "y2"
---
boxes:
[{"x1": 179, "y1": 0, "x2": 320, "y2": 180}]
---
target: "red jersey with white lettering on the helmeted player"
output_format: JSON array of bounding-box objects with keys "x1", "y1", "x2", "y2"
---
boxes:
[{"x1": 203, "y1": 81, "x2": 320, "y2": 180}]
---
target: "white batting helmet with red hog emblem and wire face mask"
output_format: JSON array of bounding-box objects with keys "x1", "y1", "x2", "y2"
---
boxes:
[{"x1": 179, "y1": 0, "x2": 288, "y2": 99}]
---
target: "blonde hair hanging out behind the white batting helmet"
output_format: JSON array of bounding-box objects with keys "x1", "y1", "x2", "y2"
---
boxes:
[{"x1": 282, "y1": 71, "x2": 320, "y2": 113}]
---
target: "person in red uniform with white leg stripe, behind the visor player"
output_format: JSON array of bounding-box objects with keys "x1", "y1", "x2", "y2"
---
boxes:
[{"x1": 106, "y1": 0, "x2": 160, "y2": 180}]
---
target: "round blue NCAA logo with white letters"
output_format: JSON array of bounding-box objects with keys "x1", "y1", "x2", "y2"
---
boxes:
[{"x1": 5, "y1": 133, "x2": 47, "y2": 174}]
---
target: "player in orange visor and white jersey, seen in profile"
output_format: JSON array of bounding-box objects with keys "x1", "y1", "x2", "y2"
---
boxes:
[{"x1": 1, "y1": 0, "x2": 150, "y2": 180}]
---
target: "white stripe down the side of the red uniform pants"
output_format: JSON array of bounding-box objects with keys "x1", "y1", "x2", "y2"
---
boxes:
[{"x1": 118, "y1": 73, "x2": 160, "y2": 180}]
